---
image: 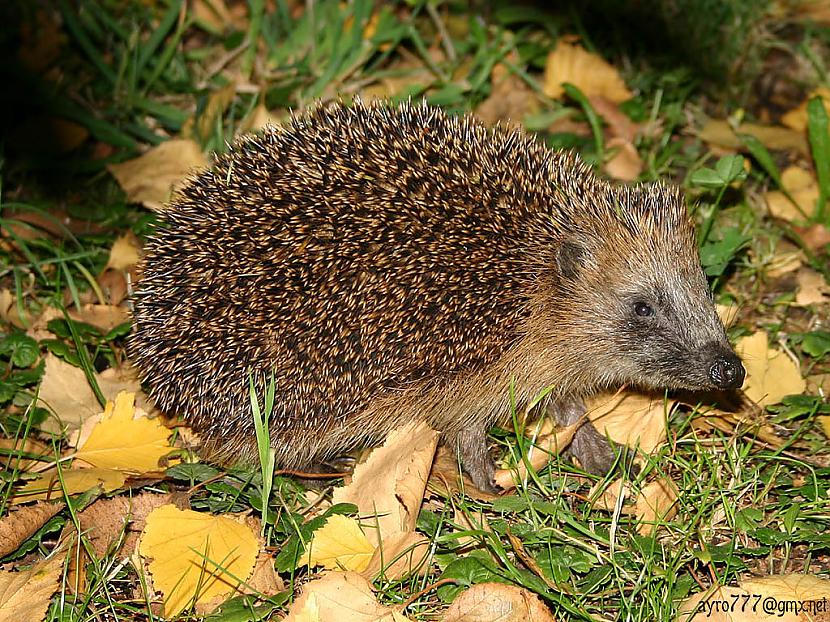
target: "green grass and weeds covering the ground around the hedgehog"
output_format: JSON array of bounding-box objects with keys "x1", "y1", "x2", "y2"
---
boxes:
[{"x1": 0, "y1": 0, "x2": 830, "y2": 622}]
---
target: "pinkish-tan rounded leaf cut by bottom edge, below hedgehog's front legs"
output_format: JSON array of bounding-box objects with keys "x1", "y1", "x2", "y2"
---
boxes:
[{"x1": 442, "y1": 583, "x2": 555, "y2": 622}]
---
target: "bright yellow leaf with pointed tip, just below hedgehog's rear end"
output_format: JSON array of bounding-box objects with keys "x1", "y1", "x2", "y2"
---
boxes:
[{"x1": 75, "y1": 391, "x2": 173, "y2": 473}]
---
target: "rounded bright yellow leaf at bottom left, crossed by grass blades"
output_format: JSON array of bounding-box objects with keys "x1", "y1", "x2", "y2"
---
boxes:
[{"x1": 139, "y1": 505, "x2": 259, "y2": 617}]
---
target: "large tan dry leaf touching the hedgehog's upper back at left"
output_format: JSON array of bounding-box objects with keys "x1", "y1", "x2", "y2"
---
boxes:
[{"x1": 107, "y1": 139, "x2": 208, "y2": 211}]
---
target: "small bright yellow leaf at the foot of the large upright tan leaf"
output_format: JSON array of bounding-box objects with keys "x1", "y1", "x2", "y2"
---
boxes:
[{"x1": 300, "y1": 514, "x2": 375, "y2": 572}]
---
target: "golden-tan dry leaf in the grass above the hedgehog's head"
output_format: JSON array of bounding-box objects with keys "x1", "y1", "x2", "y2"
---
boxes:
[{"x1": 542, "y1": 38, "x2": 633, "y2": 103}]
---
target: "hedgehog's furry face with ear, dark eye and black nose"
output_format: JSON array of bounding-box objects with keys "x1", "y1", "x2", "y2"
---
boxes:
[{"x1": 559, "y1": 219, "x2": 744, "y2": 390}]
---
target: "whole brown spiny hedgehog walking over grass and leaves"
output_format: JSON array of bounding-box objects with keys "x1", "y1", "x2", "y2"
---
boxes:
[{"x1": 129, "y1": 100, "x2": 744, "y2": 490}]
